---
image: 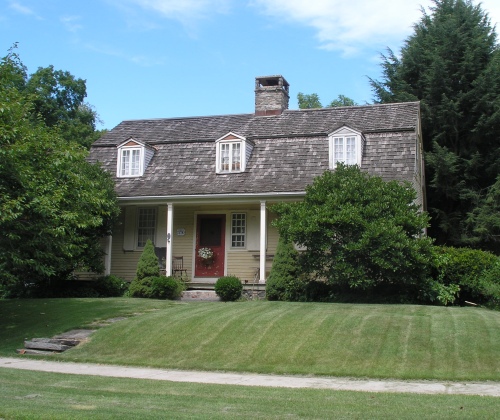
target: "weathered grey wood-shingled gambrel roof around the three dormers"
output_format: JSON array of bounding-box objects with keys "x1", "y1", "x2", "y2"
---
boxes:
[{"x1": 90, "y1": 102, "x2": 419, "y2": 198}]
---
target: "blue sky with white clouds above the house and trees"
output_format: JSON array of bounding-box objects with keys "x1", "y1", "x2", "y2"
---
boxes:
[{"x1": 0, "y1": 0, "x2": 500, "y2": 128}]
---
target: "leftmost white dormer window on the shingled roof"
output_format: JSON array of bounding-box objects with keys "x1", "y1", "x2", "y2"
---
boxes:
[{"x1": 116, "y1": 138, "x2": 154, "y2": 178}]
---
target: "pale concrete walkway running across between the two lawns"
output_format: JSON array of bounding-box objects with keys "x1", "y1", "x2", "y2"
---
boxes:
[{"x1": 0, "y1": 357, "x2": 500, "y2": 397}]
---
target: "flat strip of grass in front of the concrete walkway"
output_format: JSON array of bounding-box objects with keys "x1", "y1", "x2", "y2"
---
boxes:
[{"x1": 0, "y1": 369, "x2": 500, "y2": 420}]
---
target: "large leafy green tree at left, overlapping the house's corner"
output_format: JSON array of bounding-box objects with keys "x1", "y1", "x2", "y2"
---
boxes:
[{"x1": 0, "y1": 48, "x2": 119, "y2": 290}]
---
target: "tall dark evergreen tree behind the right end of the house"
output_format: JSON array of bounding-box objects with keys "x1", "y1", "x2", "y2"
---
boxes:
[{"x1": 371, "y1": 0, "x2": 500, "y2": 252}]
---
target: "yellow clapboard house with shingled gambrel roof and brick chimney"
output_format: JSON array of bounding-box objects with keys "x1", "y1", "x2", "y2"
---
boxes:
[{"x1": 90, "y1": 75, "x2": 425, "y2": 283}]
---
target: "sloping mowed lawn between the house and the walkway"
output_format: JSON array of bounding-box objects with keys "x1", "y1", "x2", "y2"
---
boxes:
[{"x1": 0, "y1": 299, "x2": 500, "y2": 381}]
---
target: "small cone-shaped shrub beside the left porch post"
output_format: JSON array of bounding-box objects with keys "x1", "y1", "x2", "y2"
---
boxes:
[{"x1": 129, "y1": 239, "x2": 160, "y2": 298}]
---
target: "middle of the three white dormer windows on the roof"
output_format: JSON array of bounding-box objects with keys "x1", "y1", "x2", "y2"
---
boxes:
[{"x1": 215, "y1": 133, "x2": 253, "y2": 174}]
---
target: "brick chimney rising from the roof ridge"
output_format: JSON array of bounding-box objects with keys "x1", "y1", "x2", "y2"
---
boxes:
[{"x1": 255, "y1": 75, "x2": 290, "y2": 116}]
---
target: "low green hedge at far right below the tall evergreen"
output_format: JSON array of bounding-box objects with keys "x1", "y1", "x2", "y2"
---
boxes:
[{"x1": 433, "y1": 243, "x2": 499, "y2": 305}]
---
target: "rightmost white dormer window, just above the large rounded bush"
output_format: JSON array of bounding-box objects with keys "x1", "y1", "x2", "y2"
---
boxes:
[{"x1": 328, "y1": 126, "x2": 364, "y2": 169}]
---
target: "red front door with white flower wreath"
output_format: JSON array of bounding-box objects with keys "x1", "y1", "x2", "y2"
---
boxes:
[{"x1": 194, "y1": 214, "x2": 226, "y2": 277}]
